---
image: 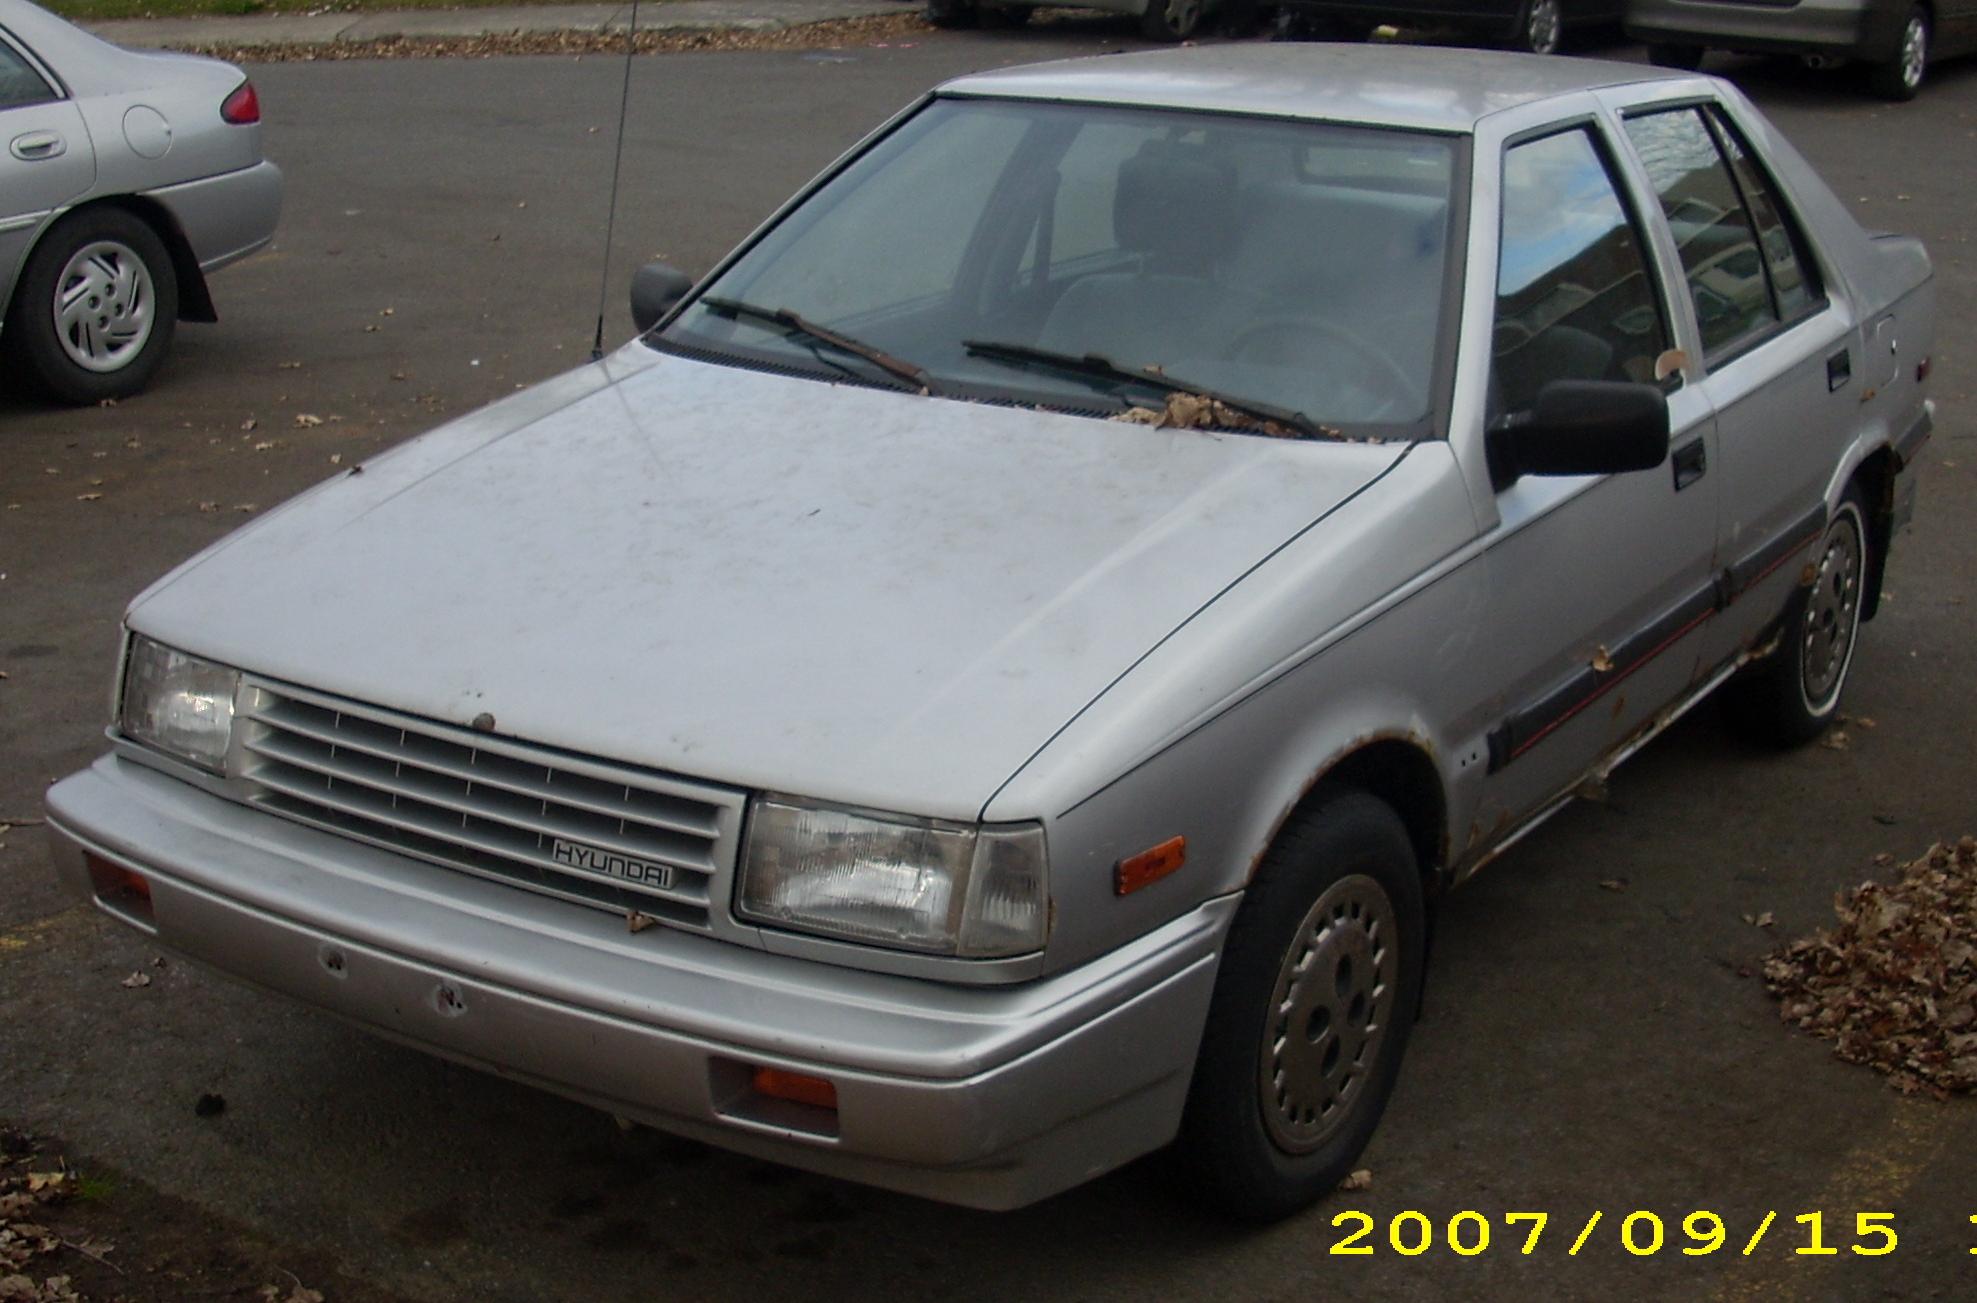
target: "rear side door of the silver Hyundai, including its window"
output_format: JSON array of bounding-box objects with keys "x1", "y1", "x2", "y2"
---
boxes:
[{"x1": 1625, "y1": 103, "x2": 1858, "y2": 664}]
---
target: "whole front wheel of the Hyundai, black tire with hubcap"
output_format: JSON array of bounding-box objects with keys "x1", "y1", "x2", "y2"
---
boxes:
[{"x1": 1176, "y1": 789, "x2": 1425, "y2": 1222}]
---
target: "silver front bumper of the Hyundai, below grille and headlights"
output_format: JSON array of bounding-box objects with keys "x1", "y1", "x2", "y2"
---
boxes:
[{"x1": 47, "y1": 755, "x2": 1236, "y2": 1208}]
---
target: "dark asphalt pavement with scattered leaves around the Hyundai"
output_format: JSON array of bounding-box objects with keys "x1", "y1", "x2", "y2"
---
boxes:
[{"x1": 0, "y1": 20, "x2": 1977, "y2": 1301}]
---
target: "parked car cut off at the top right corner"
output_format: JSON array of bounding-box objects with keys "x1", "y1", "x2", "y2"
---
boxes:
[{"x1": 1625, "y1": 0, "x2": 1977, "y2": 99}]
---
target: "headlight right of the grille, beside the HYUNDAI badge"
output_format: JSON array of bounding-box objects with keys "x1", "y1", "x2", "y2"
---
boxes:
[{"x1": 737, "y1": 799, "x2": 1050, "y2": 959}]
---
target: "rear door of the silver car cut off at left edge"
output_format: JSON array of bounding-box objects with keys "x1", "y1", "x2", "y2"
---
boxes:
[{"x1": 0, "y1": 30, "x2": 97, "y2": 310}]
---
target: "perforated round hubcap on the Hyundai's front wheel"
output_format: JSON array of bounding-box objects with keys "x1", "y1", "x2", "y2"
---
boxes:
[{"x1": 1257, "y1": 874, "x2": 1400, "y2": 1153}]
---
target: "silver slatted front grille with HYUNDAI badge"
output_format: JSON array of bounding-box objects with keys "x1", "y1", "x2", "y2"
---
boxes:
[{"x1": 243, "y1": 684, "x2": 741, "y2": 931}]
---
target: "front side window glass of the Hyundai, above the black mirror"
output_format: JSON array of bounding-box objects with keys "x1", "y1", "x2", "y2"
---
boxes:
[{"x1": 1491, "y1": 129, "x2": 1669, "y2": 417}]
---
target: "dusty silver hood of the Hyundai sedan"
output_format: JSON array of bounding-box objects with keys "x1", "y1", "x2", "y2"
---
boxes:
[{"x1": 130, "y1": 344, "x2": 1400, "y2": 819}]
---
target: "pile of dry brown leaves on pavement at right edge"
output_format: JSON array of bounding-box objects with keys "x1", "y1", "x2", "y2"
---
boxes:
[{"x1": 1763, "y1": 836, "x2": 1977, "y2": 1097}]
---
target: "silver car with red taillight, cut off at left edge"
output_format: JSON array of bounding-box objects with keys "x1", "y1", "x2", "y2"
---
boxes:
[{"x1": 0, "y1": 0, "x2": 281, "y2": 403}]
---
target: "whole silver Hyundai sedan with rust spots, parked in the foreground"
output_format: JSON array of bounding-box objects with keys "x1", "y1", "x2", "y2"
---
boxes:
[{"x1": 47, "y1": 45, "x2": 1934, "y2": 1218}]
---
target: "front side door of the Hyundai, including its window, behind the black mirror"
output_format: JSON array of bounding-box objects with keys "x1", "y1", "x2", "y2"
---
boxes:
[{"x1": 1483, "y1": 123, "x2": 1716, "y2": 832}]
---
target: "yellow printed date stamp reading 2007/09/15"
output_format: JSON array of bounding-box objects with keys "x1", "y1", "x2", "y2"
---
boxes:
[{"x1": 1331, "y1": 1208, "x2": 1977, "y2": 1258}]
